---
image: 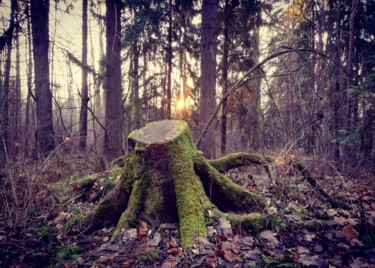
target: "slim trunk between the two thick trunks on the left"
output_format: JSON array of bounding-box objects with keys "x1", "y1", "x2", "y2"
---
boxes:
[{"x1": 79, "y1": 0, "x2": 89, "y2": 151}]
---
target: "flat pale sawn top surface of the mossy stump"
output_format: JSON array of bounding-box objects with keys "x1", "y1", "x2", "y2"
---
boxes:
[{"x1": 129, "y1": 120, "x2": 186, "y2": 144}]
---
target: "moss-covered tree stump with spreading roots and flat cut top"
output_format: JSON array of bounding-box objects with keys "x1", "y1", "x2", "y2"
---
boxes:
[{"x1": 83, "y1": 120, "x2": 266, "y2": 246}]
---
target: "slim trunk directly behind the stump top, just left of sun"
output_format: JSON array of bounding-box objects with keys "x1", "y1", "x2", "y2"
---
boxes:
[{"x1": 167, "y1": 0, "x2": 173, "y2": 119}]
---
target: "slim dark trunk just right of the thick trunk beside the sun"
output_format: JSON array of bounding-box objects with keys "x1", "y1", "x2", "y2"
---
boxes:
[{"x1": 221, "y1": 0, "x2": 229, "y2": 155}]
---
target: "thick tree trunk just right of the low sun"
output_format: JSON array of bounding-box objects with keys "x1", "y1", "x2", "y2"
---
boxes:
[{"x1": 199, "y1": 0, "x2": 217, "y2": 158}]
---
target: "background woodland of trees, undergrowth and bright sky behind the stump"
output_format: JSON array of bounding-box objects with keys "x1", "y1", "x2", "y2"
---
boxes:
[{"x1": 0, "y1": 0, "x2": 375, "y2": 266}]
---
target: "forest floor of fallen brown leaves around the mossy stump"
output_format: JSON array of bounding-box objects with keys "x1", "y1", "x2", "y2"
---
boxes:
[{"x1": 0, "y1": 156, "x2": 375, "y2": 268}]
